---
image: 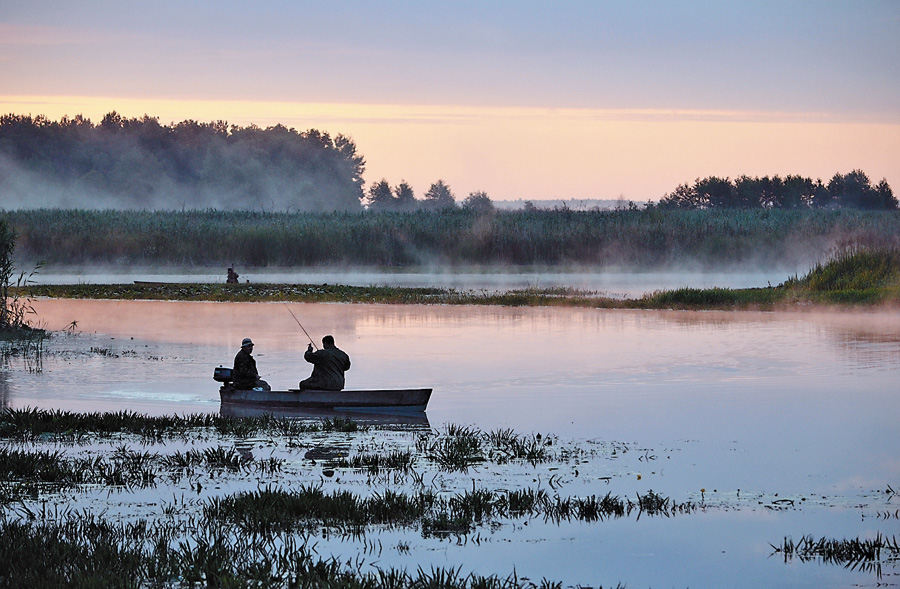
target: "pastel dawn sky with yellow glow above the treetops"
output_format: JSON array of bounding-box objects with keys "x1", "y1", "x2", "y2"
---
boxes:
[{"x1": 0, "y1": 0, "x2": 900, "y2": 202}]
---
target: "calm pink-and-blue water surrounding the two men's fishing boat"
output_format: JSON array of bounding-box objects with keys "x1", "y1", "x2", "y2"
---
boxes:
[{"x1": 7, "y1": 300, "x2": 900, "y2": 587}]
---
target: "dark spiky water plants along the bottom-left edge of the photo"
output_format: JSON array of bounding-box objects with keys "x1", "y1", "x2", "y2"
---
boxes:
[{"x1": 0, "y1": 514, "x2": 608, "y2": 589}]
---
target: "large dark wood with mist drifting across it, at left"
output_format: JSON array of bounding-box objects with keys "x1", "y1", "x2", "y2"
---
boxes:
[{"x1": 0, "y1": 112, "x2": 365, "y2": 211}]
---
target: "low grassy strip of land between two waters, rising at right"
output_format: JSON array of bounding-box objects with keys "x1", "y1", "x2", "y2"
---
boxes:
[{"x1": 18, "y1": 248, "x2": 900, "y2": 309}]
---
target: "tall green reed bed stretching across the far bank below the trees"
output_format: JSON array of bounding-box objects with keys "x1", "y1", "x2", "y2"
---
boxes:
[{"x1": 5, "y1": 207, "x2": 900, "y2": 270}]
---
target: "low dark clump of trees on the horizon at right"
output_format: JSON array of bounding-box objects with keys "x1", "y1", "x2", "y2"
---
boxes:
[{"x1": 657, "y1": 170, "x2": 898, "y2": 210}]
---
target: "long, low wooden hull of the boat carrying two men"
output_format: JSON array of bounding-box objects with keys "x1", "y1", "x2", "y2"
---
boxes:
[{"x1": 219, "y1": 386, "x2": 431, "y2": 413}]
